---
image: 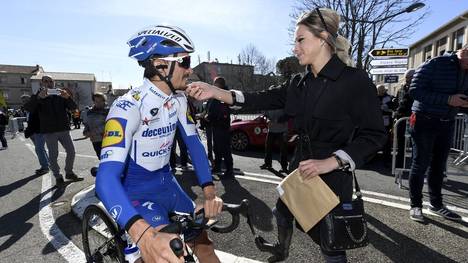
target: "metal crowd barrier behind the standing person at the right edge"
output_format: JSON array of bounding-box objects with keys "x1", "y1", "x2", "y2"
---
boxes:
[{"x1": 392, "y1": 114, "x2": 468, "y2": 188}]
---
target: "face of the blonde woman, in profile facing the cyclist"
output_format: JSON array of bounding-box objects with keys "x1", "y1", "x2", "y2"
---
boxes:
[{"x1": 293, "y1": 25, "x2": 323, "y2": 66}]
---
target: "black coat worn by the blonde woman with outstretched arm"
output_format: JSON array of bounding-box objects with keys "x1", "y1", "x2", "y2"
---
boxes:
[{"x1": 236, "y1": 55, "x2": 386, "y2": 200}]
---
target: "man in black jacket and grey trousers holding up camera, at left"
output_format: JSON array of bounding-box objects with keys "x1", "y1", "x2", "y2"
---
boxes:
[{"x1": 24, "y1": 75, "x2": 83, "y2": 187}]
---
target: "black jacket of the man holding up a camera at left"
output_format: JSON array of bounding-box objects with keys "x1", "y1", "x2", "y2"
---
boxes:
[{"x1": 24, "y1": 95, "x2": 77, "y2": 133}]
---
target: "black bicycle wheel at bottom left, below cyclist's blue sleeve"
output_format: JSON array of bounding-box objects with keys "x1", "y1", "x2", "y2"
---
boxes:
[{"x1": 82, "y1": 205, "x2": 125, "y2": 263}]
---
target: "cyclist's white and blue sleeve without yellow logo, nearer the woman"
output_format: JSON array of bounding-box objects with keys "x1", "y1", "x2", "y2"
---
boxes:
[{"x1": 177, "y1": 96, "x2": 213, "y2": 187}]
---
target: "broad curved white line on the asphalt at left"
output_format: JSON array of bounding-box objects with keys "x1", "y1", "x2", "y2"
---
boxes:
[{"x1": 23, "y1": 141, "x2": 86, "y2": 263}]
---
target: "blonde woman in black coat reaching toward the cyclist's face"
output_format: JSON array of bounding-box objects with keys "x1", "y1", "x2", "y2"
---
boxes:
[{"x1": 187, "y1": 8, "x2": 386, "y2": 262}]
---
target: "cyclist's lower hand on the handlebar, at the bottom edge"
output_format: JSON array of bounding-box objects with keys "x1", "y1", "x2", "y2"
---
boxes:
[{"x1": 129, "y1": 219, "x2": 186, "y2": 263}]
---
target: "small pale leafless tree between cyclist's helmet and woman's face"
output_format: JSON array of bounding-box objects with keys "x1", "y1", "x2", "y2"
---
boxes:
[{"x1": 238, "y1": 44, "x2": 276, "y2": 75}]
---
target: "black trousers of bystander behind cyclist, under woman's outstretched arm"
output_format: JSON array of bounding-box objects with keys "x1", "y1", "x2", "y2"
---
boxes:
[{"x1": 213, "y1": 126, "x2": 233, "y2": 171}]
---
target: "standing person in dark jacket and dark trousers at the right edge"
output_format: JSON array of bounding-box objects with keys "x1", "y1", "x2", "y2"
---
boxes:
[{"x1": 409, "y1": 45, "x2": 468, "y2": 222}]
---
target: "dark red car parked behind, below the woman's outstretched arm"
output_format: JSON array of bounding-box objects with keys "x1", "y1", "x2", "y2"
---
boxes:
[{"x1": 231, "y1": 115, "x2": 293, "y2": 151}]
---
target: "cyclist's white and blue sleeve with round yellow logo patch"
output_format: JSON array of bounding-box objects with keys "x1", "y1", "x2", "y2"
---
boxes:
[{"x1": 96, "y1": 98, "x2": 142, "y2": 231}]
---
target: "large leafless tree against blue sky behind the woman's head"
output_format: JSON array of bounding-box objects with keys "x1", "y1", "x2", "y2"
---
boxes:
[{"x1": 290, "y1": 0, "x2": 429, "y2": 69}]
